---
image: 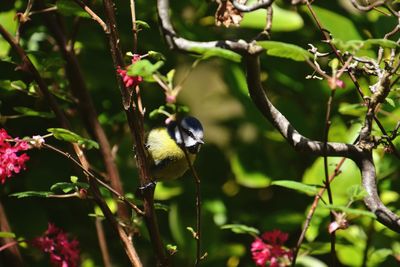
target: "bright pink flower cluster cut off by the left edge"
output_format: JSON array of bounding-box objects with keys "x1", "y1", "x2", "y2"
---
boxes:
[{"x1": 0, "y1": 129, "x2": 30, "y2": 184}]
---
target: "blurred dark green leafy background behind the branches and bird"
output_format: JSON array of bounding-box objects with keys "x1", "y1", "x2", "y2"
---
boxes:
[{"x1": 0, "y1": 0, "x2": 400, "y2": 267}]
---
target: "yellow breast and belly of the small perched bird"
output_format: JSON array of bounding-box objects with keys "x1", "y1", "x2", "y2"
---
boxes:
[{"x1": 146, "y1": 128, "x2": 196, "y2": 180}]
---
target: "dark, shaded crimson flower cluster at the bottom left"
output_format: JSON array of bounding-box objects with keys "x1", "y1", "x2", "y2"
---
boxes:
[{"x1": 32, "y1": 223, "x2": 79, "y2": 267}]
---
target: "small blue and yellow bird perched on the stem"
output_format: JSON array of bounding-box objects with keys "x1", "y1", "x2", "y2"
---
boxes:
[{"x1": 146, "y1": 116, "x2": 204, "y2": 181}]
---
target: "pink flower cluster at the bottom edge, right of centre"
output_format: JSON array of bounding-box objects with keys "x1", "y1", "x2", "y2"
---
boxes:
[{"x1": 251, "y1": 230, "x2": 292, "y2": 267}]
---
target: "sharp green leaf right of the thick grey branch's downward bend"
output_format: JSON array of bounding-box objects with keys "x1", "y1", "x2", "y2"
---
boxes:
[{"x1": 257, "y1": 41, "x2": 312, "y2": 61}]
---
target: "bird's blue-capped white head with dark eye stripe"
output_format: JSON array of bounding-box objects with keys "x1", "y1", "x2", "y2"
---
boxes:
[{"x1": 168, "y1": 116, "x2": 204, "y2": 154}]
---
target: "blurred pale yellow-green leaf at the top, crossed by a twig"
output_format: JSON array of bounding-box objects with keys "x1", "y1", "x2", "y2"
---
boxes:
[{"x1": 240, "y1": 4, "x2": 304, "y2": 32}]
